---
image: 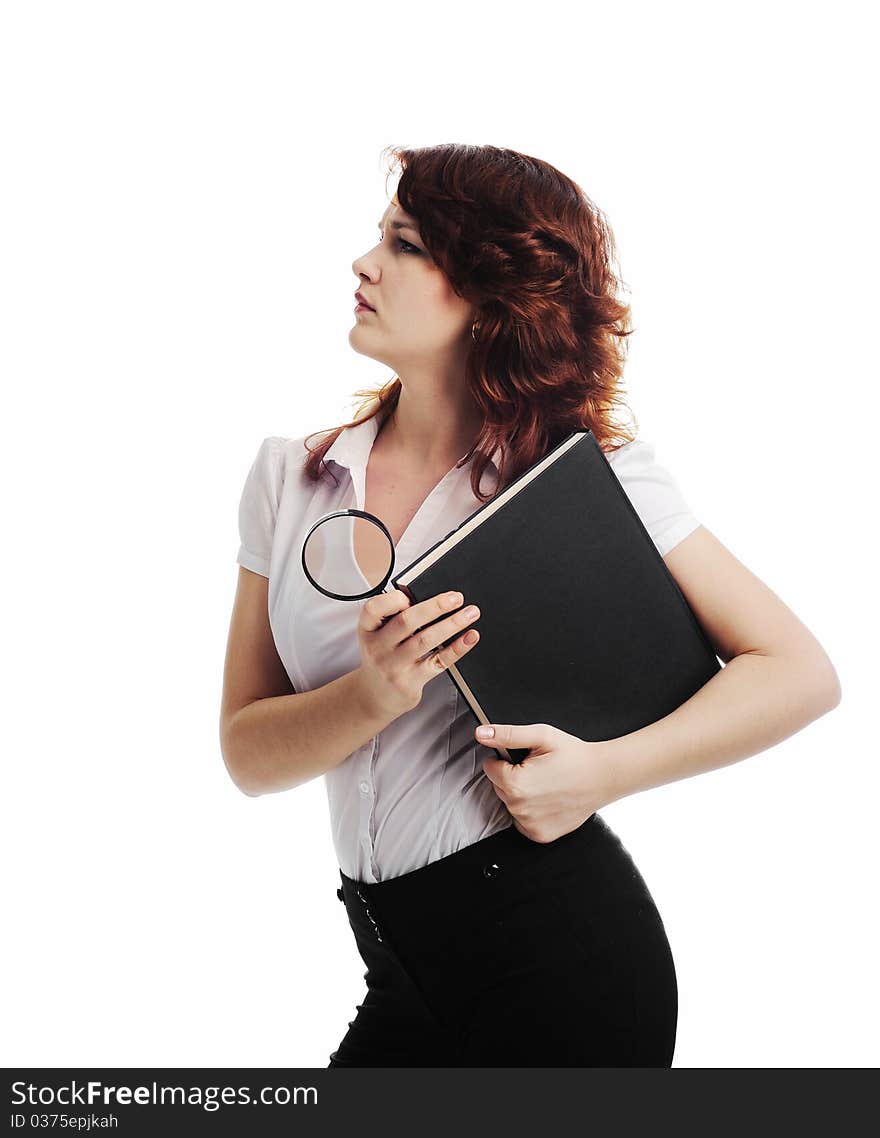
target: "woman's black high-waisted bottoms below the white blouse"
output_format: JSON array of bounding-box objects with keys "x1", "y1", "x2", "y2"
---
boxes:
[{"x1": 329, "y1": 814, "x2": 678, "y2": 1067}]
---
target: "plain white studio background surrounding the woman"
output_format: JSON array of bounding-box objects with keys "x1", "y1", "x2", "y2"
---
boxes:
[{"x1": 0, "y1": 0, "x2": 880, "y2": 1067}]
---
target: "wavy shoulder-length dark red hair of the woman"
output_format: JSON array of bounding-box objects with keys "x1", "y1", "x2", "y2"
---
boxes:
[{"x1": 303, "y1": 142, "x2": 638, "y2": 502}]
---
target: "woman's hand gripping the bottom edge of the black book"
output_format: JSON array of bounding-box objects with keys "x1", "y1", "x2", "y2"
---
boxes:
[{"x1": 475, "y1": 723, "x2": 618, "y2": 842}]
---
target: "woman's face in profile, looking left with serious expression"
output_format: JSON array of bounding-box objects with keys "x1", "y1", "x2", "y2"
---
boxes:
[{"x1": 348, "y1": 199, "x2": 475, "y2": 372}]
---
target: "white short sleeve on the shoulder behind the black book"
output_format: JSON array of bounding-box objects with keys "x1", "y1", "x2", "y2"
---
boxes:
[{"x1": 606, "y1": 439, "x2": 700, "y2": 556}]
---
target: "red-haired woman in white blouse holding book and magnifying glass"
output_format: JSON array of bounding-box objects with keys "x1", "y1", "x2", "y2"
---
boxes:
[{"x1": 221, "y1": 145, "x2": 840, "y2": 1066}]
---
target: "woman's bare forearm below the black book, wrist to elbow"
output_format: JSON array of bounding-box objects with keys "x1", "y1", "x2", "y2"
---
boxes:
[{"x1": 601, "y1": 652, "x2": 840, "y2": 802}]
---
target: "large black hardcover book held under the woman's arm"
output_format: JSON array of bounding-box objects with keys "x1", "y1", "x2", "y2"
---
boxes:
[{"x1": 392, "y1": 430, "x2": 721, "y2": 762}]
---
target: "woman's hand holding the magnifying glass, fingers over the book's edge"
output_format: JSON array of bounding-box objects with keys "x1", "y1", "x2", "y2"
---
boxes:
[{"x1": 357, "y1": 588, "x2": 479, "y2": 719}]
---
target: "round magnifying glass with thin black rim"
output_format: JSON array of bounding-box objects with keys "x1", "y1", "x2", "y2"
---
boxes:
[{"x1": 303, "y1": 510, "x2": 394, "y2": 601}]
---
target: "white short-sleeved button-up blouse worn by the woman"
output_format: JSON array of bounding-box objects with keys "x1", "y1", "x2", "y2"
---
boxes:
[{"x1": 237, "y1": 404, "x2": 699, "y2": 882}]
